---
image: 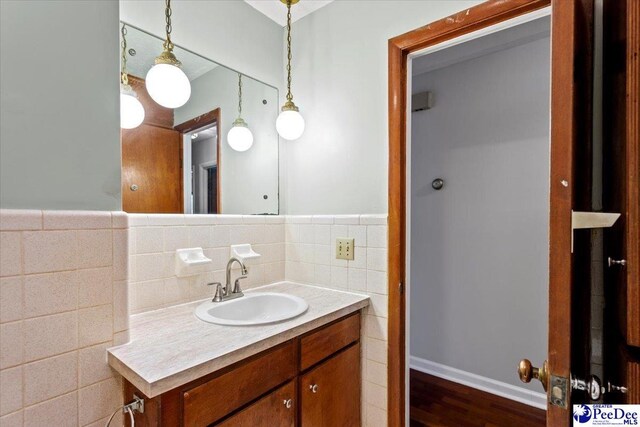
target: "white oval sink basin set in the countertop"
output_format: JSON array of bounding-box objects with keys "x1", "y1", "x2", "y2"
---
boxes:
[{"x1": 196, "y1": 292, "x2": 309, "y2": 325}]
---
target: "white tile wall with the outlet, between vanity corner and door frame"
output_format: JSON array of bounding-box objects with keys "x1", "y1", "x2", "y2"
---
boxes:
[{"x1": 284, "y1": 215, "x2": 388, "y2": 426}]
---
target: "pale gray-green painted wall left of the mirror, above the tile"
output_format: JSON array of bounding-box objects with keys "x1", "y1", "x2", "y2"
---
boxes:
[{"x1": 0, "y1": 0, "x2": 121, "y2": 210}]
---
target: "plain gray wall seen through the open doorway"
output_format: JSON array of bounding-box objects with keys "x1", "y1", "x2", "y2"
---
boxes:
[{"x1": 410, "y1": 38, "x2": 550, "y2": 391}]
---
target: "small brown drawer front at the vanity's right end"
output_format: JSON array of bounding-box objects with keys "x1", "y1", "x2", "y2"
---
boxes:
[{"x1": 300, "y1": 312, "x2": 360, "y2": 370}]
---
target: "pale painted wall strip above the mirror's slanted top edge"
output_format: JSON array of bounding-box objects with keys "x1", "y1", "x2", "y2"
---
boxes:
[{"x1": 120, "y1": 0, "x2": 282, "y2": 87}]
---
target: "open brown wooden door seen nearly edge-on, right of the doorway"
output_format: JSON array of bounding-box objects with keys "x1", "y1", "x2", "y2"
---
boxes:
[{"x1": 547, "y1": 0, "x2": 593, "y2": 427}]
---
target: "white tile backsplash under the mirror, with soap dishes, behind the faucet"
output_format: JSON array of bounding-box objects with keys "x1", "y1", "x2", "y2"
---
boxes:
[{"x1": 129, "y1": 214, "x2": 285, "y2": 314}]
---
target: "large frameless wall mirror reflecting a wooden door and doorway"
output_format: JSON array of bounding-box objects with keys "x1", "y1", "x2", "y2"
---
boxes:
[{"x1": 120, "y1": 22, "x2": 279, "y2": 215}]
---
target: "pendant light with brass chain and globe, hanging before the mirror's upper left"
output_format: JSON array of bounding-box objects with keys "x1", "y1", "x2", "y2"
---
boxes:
[{"x1": 146, "y1": 0, "x2": 191, "y2": 108}]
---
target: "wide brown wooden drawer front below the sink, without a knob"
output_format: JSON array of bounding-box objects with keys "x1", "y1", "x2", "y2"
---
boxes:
[{"x1": 182, "y1": 342, "x2": 297, "y2": 427}]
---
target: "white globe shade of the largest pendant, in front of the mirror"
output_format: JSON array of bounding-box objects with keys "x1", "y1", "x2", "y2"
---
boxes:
[{"x1": 146, "y1": 64, "x2": 191, "y2": 108}]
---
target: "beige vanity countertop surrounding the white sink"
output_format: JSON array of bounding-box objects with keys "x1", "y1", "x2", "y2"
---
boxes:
[{"x1": 107, "y1": 282, "x2": 369, "y2": 397}]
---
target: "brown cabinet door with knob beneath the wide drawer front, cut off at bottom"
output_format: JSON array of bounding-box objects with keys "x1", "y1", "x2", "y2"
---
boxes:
[{"x1": 216, "y1": 381, "x2": 298, "y2": 427}]
